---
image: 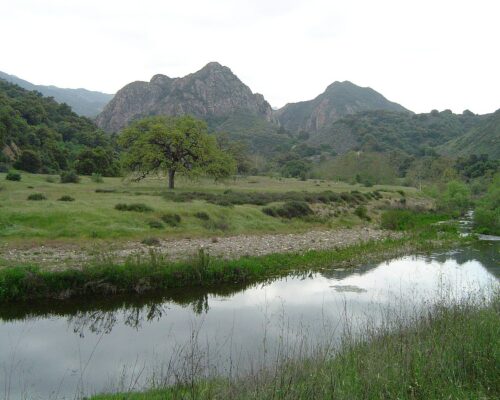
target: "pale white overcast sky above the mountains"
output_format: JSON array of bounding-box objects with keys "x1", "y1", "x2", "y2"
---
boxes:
[{"x1": 0, "y1": 0, "x2": 500, "y2": 113}]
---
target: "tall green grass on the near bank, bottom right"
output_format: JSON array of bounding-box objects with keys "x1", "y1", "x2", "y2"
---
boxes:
[{"x1": 92, "y1": 294, "x2": 500, "y2": 400}]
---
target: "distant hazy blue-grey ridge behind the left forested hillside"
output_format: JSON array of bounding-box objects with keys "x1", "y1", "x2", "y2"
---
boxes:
[{"x1": 0, "y1": 71, "x2": 113, "y2": 118}]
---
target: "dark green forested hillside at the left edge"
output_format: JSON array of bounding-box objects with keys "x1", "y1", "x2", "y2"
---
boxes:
[{"x1": 0, "y1": 79, "x2": 117, "y2": 175}]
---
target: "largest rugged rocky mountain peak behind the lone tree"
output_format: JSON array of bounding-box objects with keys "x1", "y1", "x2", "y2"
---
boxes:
[{"x1": 96, "y1": 62, "x2": 274, "y2": 132}]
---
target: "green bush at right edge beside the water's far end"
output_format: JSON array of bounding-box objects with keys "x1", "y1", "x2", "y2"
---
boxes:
[{"x1": 474, "y1": 174, "x2": 500, "y2": 235}]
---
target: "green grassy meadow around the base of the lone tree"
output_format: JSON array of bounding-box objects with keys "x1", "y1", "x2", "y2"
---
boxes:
[{"x1": 0, "y1": 173, "x2": 420, "y2": 242}]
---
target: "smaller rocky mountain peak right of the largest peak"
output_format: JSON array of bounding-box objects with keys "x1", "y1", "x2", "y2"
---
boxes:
[{"x1": 275, "y1": 81, "x2": 408, "y2": 133}]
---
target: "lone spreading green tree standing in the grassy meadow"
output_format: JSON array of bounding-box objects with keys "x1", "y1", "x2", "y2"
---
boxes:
[{"x1": 120, "y1": 116, "x2": 235, "y2": 189}]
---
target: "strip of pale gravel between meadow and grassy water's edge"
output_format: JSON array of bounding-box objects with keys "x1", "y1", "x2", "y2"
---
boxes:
[{"x1": 0, "y1": 227, "x2": 400, "y2": 268}]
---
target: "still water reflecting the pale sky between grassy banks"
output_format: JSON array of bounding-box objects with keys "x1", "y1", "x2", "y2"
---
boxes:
[{"x1": 0, "y1": 241, "x2": 500, "y2": 399}]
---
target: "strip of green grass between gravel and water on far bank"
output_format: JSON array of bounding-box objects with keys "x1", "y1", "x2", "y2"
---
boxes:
[{"x1": 0, "y1": 237, "x2": 454, "y2": 302}]
